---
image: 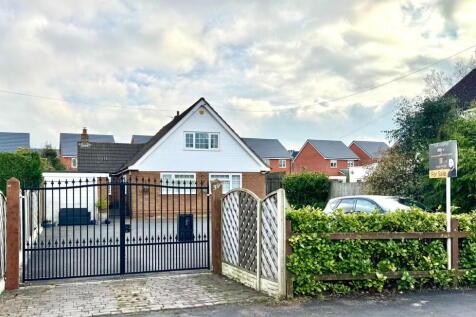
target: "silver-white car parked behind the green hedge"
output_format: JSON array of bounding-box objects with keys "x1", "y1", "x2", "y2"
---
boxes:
[{"x1": 324, "y1": 195, "x2": 430, "y2": 213}]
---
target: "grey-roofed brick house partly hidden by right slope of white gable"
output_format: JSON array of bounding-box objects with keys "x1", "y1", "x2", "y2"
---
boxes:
[{"x1": 242, "y1": 138, "x2": 291, "y2": 173}]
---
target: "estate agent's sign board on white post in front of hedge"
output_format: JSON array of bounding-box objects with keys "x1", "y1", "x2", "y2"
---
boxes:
[{"x1": 429, "y1": 140, "x2": 458, "y2": 270}]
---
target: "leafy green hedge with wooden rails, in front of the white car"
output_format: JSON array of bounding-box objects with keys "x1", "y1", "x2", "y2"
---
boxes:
[{"x1": 287, "y1": 207, "x2": 476, "y2": 295}]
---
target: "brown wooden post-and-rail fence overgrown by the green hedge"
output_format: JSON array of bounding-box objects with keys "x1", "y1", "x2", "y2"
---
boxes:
[{"x1": 286, "y1": 219, "x2": 472, "y2": 283}]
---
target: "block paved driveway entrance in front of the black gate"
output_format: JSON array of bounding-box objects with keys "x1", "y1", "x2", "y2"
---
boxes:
[{"x1": 0, "y1": 272, "x2": 267, "y2": 317}]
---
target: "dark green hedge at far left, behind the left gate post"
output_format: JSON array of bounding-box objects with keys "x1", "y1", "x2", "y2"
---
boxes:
[{"x1": 0, "y1": 151, "x2": 42, "y2": 193}]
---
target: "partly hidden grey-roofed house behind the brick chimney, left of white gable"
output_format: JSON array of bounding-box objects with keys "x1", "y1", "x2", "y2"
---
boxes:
[{"x1": 59, "y1": 128, "x2": 114, "y2": 171}]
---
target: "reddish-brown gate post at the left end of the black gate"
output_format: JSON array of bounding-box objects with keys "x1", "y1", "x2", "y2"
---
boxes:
[{"x1": 5, "y1": 177, "x2": 21, "y2": 290}]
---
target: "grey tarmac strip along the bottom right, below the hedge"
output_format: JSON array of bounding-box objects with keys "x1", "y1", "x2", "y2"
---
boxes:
[{"x1": 131, "y1": 289, "x2": 476, "y2": 317}]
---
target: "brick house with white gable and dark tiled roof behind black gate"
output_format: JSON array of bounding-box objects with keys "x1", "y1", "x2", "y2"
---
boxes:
[{"x1": 77, "y1": 98, "x2": 270, "y2": 217}]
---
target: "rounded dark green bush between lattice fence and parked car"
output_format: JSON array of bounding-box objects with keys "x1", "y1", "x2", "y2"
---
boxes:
[{"x1": 282, "y1": 172, "x2": 330, "y2": 208}]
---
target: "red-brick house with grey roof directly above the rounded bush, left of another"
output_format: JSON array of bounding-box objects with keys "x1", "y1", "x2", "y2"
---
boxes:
[{"x1": 293, "y1": 139, "x2": 359, "y2": 182}]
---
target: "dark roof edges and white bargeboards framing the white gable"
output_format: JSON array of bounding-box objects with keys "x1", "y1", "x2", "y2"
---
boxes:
[{"x1": 116, "y1": 97, "x2": 269, "y2": 173}]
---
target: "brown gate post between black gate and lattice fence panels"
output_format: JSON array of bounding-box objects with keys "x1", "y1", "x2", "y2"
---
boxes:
[{"x1": 211, "y1": 181, "x2": 223, "y2": 274}]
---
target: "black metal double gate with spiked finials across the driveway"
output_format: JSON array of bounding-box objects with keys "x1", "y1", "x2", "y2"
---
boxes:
[{"x1": 22, "y1": 175, "x2": 210, "y2": 281}]
